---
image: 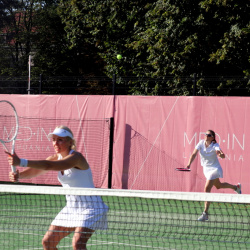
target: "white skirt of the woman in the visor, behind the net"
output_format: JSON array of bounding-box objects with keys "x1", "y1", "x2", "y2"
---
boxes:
[{"x1": 51, "y1": 195, "x2": 109, "y2": 230}]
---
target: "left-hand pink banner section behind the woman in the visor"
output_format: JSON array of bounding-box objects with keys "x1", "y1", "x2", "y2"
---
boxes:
[{"x1": 0, "y1": 95, "x2": 113, "y2": 187}]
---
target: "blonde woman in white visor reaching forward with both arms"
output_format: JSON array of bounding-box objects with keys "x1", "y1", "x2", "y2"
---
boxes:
[{"x1": 6, "y1": 126, "x2": 108, "y2": 249}]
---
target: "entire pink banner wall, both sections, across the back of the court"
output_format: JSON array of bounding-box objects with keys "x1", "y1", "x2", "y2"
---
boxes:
[{"x1": 0, "y1": 95, "x2": 250, "y2": 193}]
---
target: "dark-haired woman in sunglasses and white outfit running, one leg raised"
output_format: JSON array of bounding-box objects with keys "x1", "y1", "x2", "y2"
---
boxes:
[{"x1": 187, "y1": 130, "x2": 241, "y2": 221}]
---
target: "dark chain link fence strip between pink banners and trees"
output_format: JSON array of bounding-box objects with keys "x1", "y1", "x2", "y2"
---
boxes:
[{"x1": 0, "y1": 74, "x2": 250, "y2": 96}]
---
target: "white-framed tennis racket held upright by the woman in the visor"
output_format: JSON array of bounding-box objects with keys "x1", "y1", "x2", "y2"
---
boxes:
[{"x1": 0, "y1": 100, "x2": 18, "y2": 172}]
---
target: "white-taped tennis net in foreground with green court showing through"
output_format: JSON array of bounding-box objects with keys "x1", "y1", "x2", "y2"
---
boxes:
[{"x1": 0, "y1": 185, "x2": 250, "y2": 250}]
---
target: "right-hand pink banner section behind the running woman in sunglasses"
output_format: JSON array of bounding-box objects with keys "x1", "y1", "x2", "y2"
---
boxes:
[{"x1": 113, "y1": 96, "x2": 250, "y2": 193}]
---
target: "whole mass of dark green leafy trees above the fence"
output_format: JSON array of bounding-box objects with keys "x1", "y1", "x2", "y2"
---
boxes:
[{"x1": 0, "y1": 0, "x2": 250, "y2": 95}]
